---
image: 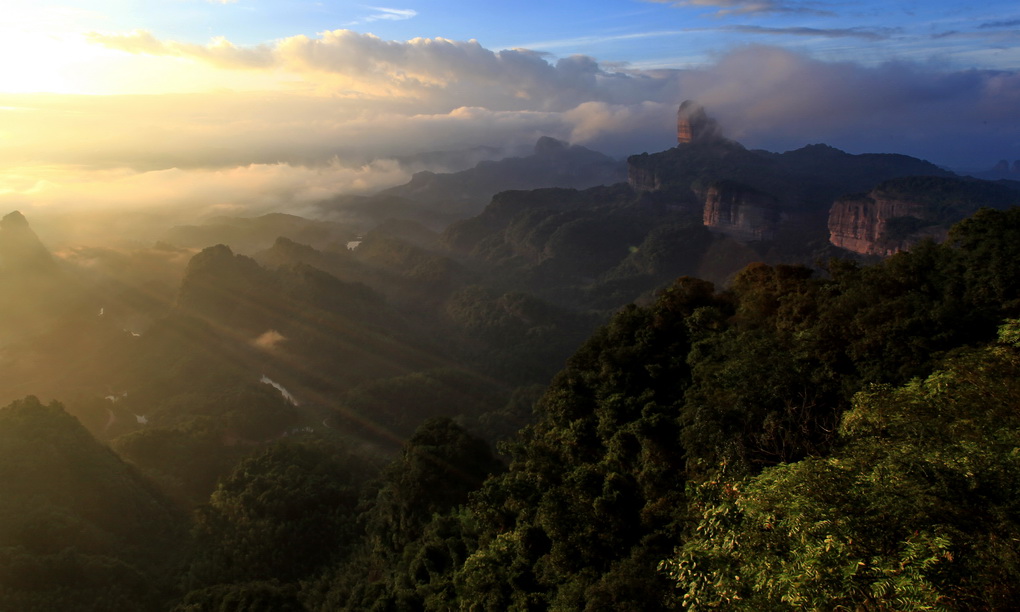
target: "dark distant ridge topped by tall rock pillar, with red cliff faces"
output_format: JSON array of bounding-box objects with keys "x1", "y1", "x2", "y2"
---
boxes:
[{"x1": 627, "y1": 106, "x2": 1017, "y2": 255}]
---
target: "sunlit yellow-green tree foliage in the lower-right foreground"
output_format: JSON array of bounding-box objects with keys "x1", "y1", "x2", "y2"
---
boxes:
[{"x1": 660, "y1": 321, "x2": 1020, "y2": 610}]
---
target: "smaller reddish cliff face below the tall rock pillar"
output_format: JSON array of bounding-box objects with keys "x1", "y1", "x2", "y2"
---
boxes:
[{"x1": 704, "y1": 182, "x2": 779, "y2": 241}]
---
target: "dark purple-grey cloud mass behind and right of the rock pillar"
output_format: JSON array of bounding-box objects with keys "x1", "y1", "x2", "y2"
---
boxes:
[{"x1": 683, "y1": 47, "x2": 1020, "y2": 167}]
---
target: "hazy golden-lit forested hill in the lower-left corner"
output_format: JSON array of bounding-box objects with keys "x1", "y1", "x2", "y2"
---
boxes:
[{"x1": 0, "y1": 397, "x2": 184, "y2": 612}]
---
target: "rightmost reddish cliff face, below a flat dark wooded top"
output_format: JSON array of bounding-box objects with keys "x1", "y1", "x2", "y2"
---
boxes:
[{"x1": 828, "y1": 191, "x2": 946, "y2": 255}]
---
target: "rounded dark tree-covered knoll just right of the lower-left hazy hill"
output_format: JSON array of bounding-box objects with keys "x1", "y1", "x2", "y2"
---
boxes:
[{"x1": 190, "y1": 444, "x2": 366, "y2": 590}]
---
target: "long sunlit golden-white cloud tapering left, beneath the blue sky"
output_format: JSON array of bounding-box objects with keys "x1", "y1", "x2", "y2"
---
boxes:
[{"x1": 91, "y1": 30, "x2": 673, "y2": 110}]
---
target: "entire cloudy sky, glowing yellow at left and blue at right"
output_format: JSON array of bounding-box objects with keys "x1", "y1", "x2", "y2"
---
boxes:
[{"x1": 0, "y1": 0, "x2": 1020, "y2": 236}]
